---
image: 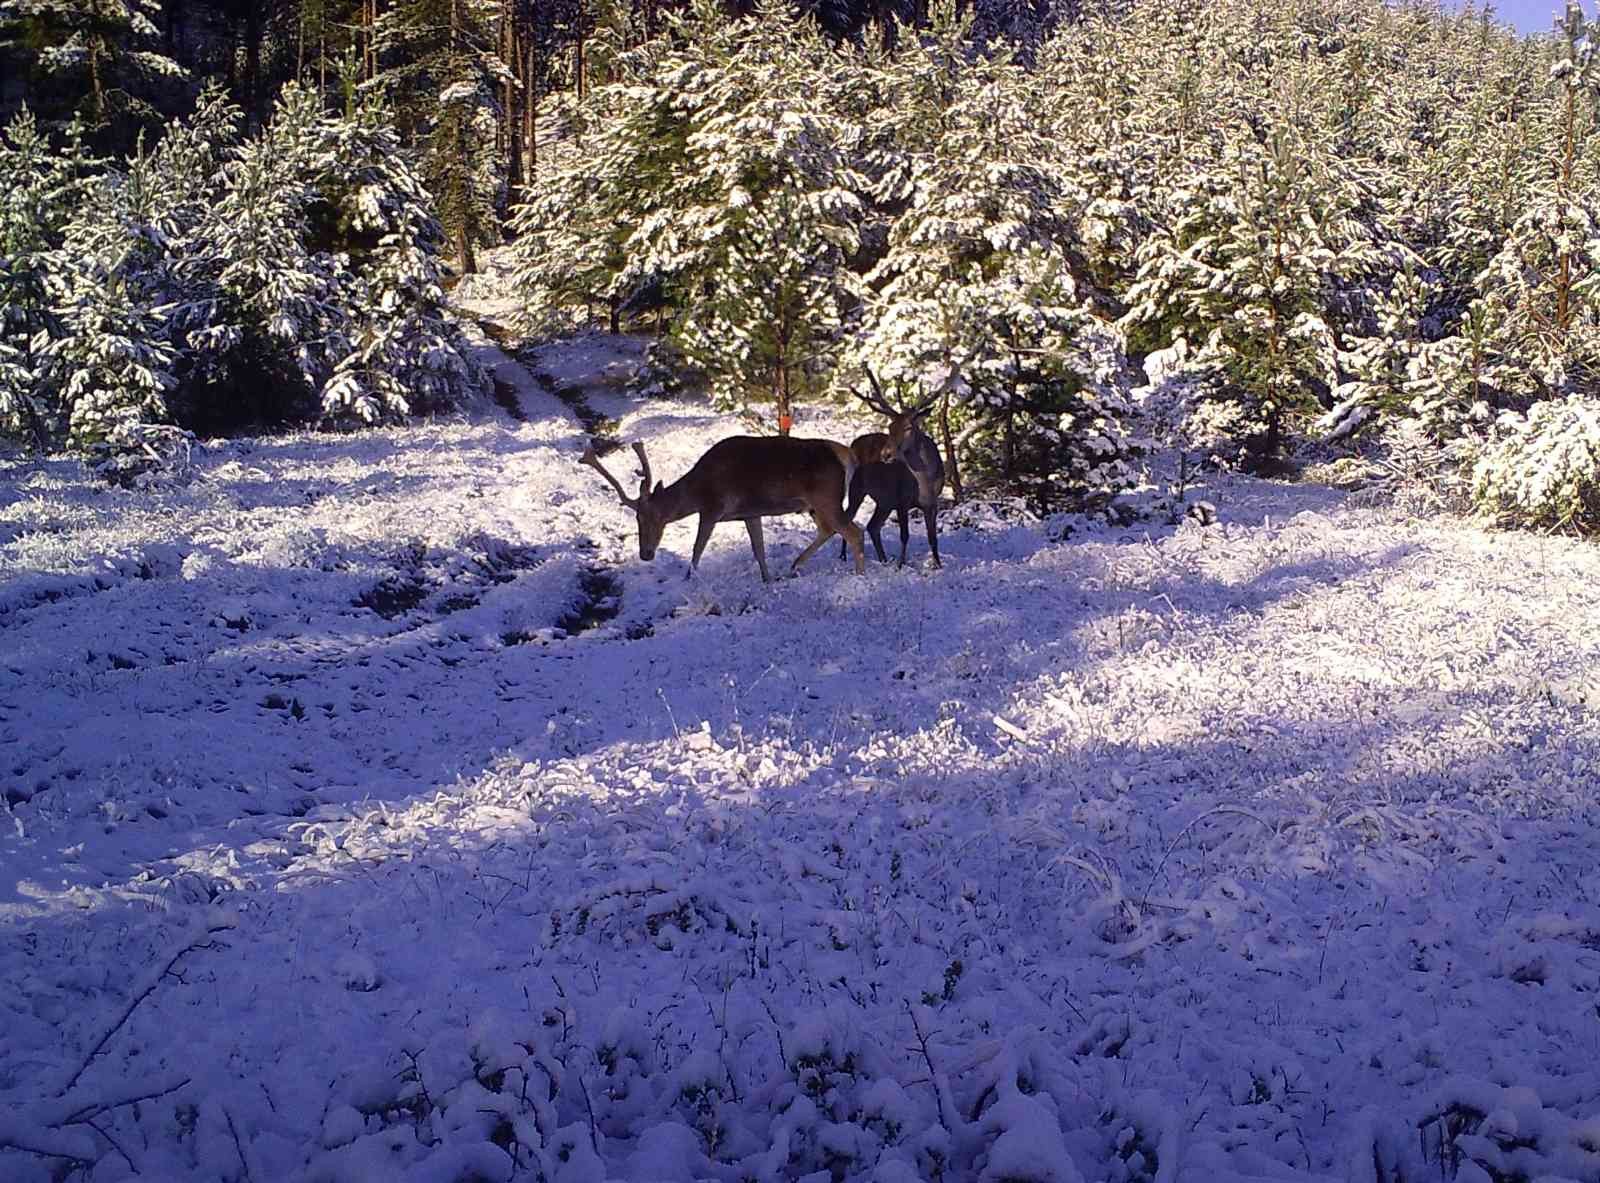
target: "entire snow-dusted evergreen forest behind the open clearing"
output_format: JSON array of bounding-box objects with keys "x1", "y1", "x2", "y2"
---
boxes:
[{"x1": 0, "y1": 0, "x2": 1600, "y2": 530}]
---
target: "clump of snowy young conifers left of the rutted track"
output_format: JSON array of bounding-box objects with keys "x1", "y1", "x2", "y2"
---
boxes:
[{"x1": 0, "y1": 78, "x2": 472, "y2": 448}]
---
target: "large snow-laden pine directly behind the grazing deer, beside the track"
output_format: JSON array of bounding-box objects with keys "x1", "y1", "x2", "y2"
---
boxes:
[{"x1": 514, "y1": 2, "x2": 864, "y2": 432}]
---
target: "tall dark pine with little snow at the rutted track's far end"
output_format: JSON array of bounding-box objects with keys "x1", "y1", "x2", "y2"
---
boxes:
[{"x1": 373, "y1": 0, "x2": 510, "y2": 274}]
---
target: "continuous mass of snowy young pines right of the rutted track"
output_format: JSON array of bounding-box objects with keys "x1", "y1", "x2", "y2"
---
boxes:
[{"x1": 514, "y1": 0, "x2": 1600, "y2": 528}]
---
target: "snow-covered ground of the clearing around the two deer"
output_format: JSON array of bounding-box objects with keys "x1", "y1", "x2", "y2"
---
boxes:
[{"x1": 0, "y1": 316, "x2": 1600, "y2": 1183}]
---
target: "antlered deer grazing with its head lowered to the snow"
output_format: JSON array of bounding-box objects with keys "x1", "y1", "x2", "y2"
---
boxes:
[{"x1": 579, "y1": 435, "x2": 867, "y2": 583}]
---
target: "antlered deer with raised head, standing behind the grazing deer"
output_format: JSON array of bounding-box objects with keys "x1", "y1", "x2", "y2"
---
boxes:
[{"x1": 840, "y1": 370, "x2": 944, "y2": 567}]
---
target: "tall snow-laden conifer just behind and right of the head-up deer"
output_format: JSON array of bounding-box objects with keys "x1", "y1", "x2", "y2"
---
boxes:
[{"x1": 845, "y1": 8, "x2": 1130, "y2": 506}]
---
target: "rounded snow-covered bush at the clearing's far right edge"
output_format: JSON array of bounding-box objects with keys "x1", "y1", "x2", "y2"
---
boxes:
[{"x1": 1472, "y1": 394, "x2": 1600, "y2": 531}]
